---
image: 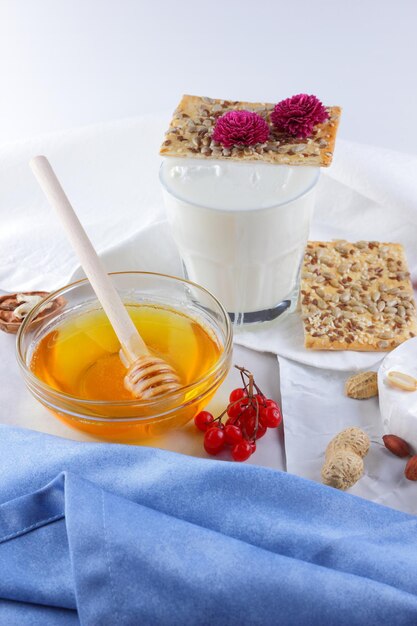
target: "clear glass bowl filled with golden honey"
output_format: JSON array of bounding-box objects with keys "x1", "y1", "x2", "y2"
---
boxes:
[{"x1": 17, "y1": 272, "x2": 233, "y2": 443}]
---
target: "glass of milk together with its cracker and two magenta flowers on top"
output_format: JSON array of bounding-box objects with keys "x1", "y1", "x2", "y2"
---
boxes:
[{"x1": 160, "y1": 94, "x2": 340, "y2": 329}]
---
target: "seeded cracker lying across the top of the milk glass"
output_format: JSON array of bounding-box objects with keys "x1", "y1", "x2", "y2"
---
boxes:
[{"x1": 160, "y1": 96, "x2": 341, "y2": 167}]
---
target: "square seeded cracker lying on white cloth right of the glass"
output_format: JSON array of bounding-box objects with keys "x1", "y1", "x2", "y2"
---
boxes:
[{"x1": 300, "y1": 241, "x2": 417, "y2": 351}]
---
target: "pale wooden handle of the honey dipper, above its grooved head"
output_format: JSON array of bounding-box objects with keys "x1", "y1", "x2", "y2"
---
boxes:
[{"x1": 30, "y1": 156, "x2": 149, "y2": 363}]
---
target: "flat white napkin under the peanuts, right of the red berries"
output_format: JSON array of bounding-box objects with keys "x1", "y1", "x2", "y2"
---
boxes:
[{"x1": 279, "y1": 354, "x2": 417, "y2": 515}]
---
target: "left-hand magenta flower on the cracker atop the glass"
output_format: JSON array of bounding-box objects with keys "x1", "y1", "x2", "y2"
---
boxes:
[{"x1": 213, "y1": 111, "x2": 269, "y2": 148}]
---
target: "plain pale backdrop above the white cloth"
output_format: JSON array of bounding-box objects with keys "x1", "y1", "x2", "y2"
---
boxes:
[{"x1": 0, "y1": 0, "x2": 417, "y2": 153}]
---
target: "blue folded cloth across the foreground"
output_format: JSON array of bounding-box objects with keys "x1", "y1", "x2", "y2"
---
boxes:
[{"x1": 0, "y1": 426, "x2": 417, "y2": 626}]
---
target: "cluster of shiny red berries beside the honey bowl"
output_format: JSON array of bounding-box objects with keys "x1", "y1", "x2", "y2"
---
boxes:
[{"x1": 194, "y1": 365, "x2": 282, "y2": 461}]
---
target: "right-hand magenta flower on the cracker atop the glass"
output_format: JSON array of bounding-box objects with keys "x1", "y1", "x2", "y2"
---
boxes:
[{"x1": 271, "y1": 93, "x2": 329, "y2": 139}]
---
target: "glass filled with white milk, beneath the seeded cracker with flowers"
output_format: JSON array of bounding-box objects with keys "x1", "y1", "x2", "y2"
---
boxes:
[{"x1": 160, "y1": 157, "x2": 320, "y2": 325}]
